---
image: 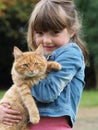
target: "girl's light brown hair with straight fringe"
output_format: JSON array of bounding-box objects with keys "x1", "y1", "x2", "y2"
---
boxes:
[{"x1": 27, "y1": 0, "x2": 88, "y2": 62}]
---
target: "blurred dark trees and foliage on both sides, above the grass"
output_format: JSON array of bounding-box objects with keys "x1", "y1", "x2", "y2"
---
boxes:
[{"x1": 0, "y1": 0, "x2": 98, "y2": 91}]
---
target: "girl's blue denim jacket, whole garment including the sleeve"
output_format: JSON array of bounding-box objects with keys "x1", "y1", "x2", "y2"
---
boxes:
[{"x1": 32, "y1": 41, "x2": 85, "y2": 126}]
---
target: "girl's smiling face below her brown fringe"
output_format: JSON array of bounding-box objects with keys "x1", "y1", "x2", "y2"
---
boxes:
[{"x1": 35, "y1": 28, "x2": 73, "y2": 55}]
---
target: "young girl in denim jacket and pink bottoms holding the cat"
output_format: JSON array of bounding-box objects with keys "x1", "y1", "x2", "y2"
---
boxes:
[{"x1": 0, "y1": 0, "x2": 87, "y2": 130}]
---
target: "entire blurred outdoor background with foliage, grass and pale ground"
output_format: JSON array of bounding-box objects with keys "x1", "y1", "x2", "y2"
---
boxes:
[{"x1": 0, "y1": 0, "x2": 98, "y2": 130}]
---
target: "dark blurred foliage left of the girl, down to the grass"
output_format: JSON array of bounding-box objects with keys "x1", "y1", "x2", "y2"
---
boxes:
[{"x1": 0, "y1": 0, "x2": 34, "y2": 87}]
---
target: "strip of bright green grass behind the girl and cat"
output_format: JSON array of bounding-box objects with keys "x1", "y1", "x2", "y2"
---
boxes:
[{"x1": 0, "y1": 90, "x2": 98, "y2": 107}]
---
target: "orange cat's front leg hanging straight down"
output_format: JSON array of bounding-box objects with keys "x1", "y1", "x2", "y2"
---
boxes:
[{"x1": 17, "y1": 84, "x2": 40, "y2": 124}]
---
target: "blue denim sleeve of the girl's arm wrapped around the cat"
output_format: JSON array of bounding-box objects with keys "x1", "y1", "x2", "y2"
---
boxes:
[{"x1": 31, "y1": 48, "x2": 83, "y2": 103}]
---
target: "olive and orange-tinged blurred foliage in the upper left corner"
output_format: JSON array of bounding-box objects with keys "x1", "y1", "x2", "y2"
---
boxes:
[{"x1": 0, "y1": 0, "x2": 33, "y2": 40}]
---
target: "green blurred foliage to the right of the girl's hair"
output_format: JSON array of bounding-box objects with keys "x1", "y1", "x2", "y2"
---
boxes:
[{"x1": 75, "y1": 0, "x2": 98, "y2": 65}]
